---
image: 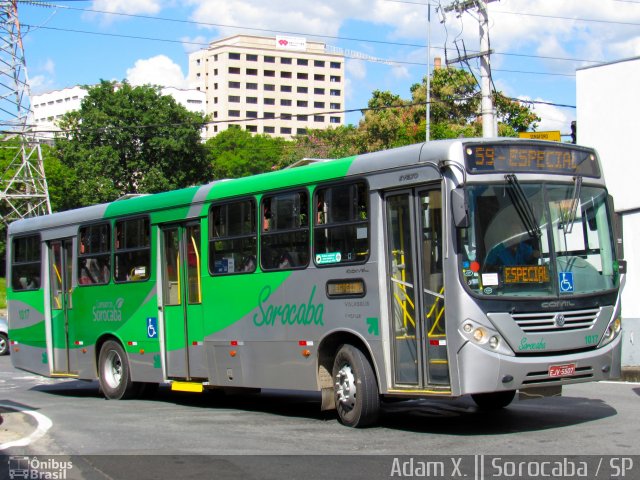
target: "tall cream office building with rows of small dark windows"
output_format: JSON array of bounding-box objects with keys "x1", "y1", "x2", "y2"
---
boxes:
[{"x1": 189, "y1": 35, "x2": 345, "y2": 138}]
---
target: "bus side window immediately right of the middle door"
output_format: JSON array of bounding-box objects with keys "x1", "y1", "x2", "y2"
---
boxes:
[{"x1": 209, "y1": 198, "x2": 258, "y2": 275}]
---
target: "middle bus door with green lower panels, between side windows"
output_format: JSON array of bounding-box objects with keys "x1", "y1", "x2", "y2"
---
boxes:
[{"x1": 161, "y1": 221, "x2": 207, "y2": 380}]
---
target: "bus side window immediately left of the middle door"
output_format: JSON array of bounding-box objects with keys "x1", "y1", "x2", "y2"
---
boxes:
[{"x1": 114, "y1": 217, "x2": 151, "y2": 282}]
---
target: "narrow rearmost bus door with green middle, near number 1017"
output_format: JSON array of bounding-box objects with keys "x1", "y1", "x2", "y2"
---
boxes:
[{"x1": 49, "y1": 238, "x2": 78, "y2": 374}]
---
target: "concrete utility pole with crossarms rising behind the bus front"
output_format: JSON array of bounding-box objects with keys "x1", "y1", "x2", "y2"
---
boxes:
[{"x1": 444, "y1": 0, "x2": 498, "y2": 137}]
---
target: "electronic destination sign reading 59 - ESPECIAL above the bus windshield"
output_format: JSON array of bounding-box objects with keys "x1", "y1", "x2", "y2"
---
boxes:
[{"x1": 464, "y1": 143, "x2": 600, "y2": 177}]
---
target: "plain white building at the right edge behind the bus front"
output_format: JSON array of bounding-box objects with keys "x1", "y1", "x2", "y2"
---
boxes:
[{"x1": 576, "y1": 57, "x2": 640, "y2": 366}]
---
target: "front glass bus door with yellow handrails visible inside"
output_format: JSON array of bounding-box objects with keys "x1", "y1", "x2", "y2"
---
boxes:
[{"x1": 385, "y1": 185, "x2": 450, "y2": 389}]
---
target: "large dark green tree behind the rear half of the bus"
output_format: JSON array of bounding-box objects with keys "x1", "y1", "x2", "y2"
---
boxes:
[{"x1": 52, "y1": 80, "x2": 212, "y2": 208}]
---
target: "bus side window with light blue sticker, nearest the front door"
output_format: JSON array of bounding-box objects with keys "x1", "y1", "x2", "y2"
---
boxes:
[{"x1": 313, "y1": 182, "x2": 369, "y2": 267}]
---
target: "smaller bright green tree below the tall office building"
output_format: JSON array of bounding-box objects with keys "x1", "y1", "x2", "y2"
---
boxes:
[{"x1": 205, "y1": 127, "x2": 289, "y2": 178}]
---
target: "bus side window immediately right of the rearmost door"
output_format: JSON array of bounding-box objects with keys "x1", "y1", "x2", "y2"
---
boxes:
[{"x1": 78, "y1": 223, "x2": 111, "y2": 285}]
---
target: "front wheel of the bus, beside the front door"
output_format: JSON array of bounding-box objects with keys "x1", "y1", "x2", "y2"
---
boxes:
[{"x1": 332, "y1": 344, "x2": 380, "y2": 427}]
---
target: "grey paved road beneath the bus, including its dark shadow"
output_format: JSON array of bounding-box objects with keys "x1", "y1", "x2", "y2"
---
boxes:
[{"x1": 0, "y1": 357, "x2": 640, "y2": 478}]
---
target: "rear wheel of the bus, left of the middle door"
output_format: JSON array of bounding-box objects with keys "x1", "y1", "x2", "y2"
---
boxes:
[{"x1": 98, "y1": 340, "x2": 140, "y2": 400}]
